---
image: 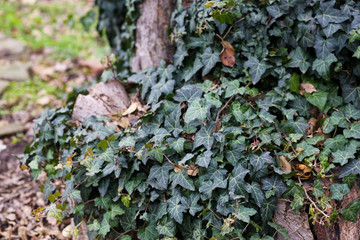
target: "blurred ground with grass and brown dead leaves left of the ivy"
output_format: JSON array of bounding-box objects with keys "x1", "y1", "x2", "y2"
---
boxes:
[{"x1": 0, "y1": 0, "x2": 110, "y2": 240}]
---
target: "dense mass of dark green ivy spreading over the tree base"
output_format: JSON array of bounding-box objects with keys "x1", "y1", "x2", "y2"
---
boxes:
[{"x1": 23, "y1": 1, "x2": 360, "y2": 239}]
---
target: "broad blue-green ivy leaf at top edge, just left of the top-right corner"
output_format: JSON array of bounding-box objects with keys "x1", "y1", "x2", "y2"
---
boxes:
[{"x1": 315, "y1": 0, "x2": 349, "y2": 27}]
